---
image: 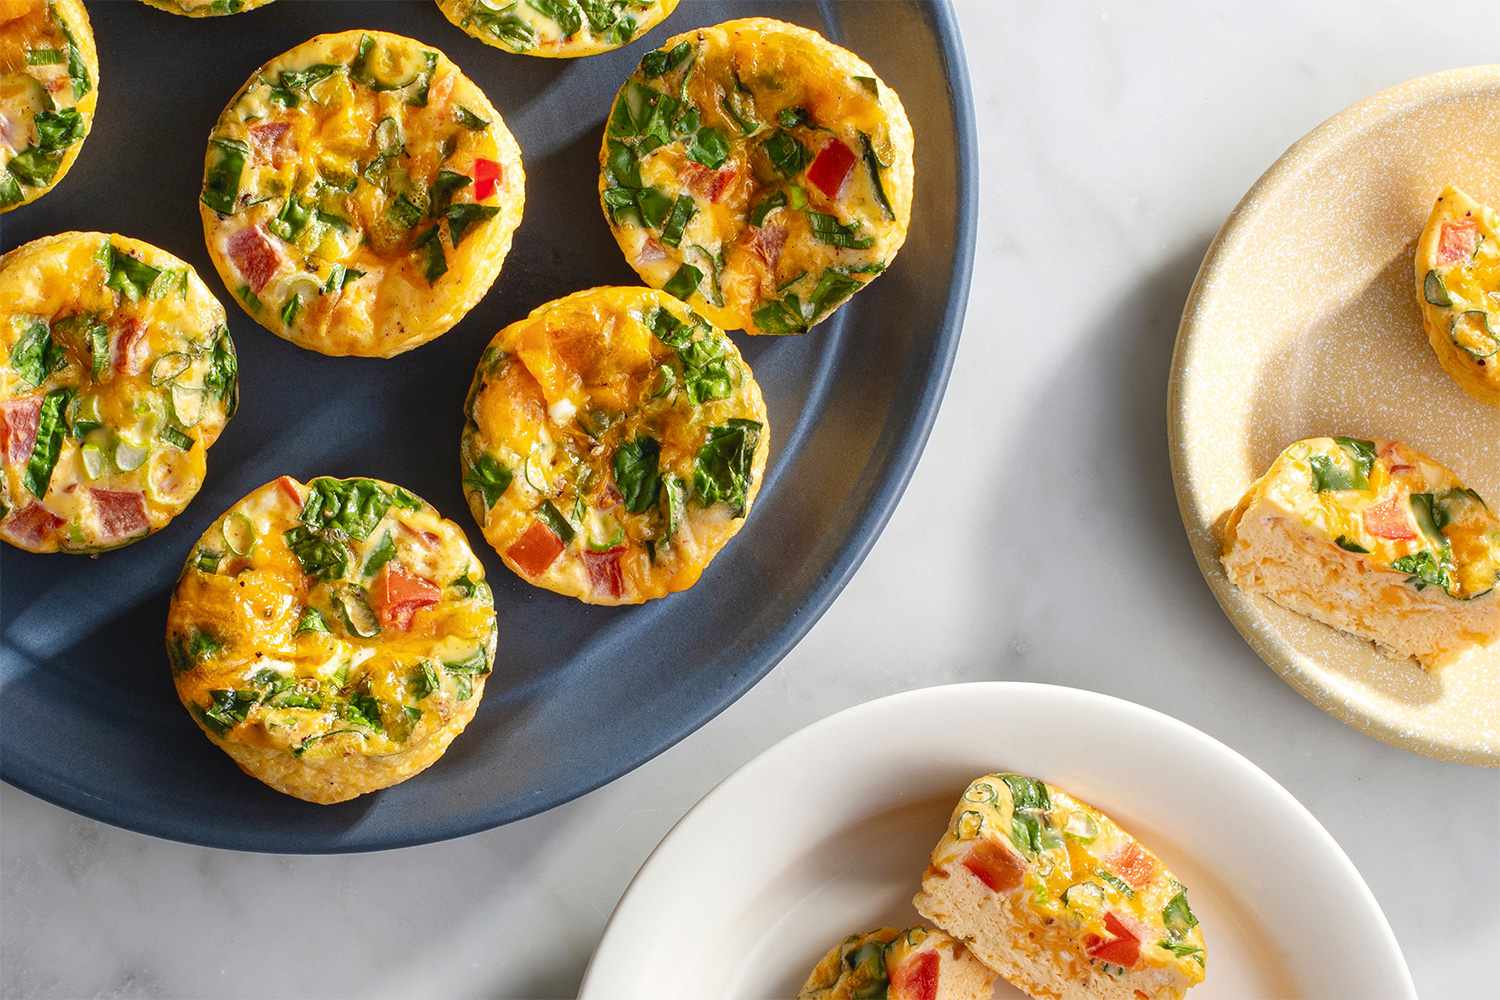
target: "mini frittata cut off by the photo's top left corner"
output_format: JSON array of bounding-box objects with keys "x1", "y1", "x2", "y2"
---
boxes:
[{"x1": 0, "y1": 0, "x2": 99, "y2": 214}]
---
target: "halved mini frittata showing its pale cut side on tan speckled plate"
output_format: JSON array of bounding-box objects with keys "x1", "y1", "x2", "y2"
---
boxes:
[{"x1": 1223, "y1": 438, "x2": 1500, "y2": 667}]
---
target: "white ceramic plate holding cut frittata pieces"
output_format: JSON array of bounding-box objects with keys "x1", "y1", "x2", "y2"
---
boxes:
[{"x1": 581, "y1": 684, "x2": 1416, "y2": 1000}]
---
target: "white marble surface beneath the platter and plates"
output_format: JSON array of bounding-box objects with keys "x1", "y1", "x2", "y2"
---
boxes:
[{"x1": 0, "y1": 0, "x2": 1500, "y2": 1000}]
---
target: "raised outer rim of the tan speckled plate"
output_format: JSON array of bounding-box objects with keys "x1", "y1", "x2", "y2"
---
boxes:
[{"x1": 1166, "y1": 64, "x2": 1500, "y2": 768}]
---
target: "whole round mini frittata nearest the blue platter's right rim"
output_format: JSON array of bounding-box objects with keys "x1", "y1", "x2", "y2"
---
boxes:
[{"x1": 599, "y1": 18, "x2": 915, "y2": 334}]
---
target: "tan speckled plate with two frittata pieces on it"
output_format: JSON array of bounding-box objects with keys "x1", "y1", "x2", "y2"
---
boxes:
[{"x1": 1167, "y1": 66, "x2": 1500, "y2": 768}]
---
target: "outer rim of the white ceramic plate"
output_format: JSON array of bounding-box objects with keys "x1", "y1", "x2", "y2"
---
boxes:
[{"x1": 579, "y1": 681, "x2": 1418, "y2": 1000}]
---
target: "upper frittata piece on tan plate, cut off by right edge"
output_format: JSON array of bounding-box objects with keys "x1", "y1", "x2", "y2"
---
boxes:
[{"x1": 1413, "y1": 187, "x2": 1500, "y2": 406}]
